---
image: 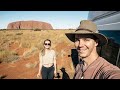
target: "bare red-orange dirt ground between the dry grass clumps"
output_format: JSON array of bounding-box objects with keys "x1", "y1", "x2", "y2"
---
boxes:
[{"x1": 0, "y1": 43, "x2": 75, "y2": 79}]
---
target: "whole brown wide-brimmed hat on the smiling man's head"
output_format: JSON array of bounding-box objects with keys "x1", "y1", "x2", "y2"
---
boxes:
[{"x1": 65, "y1": 20, "x2": 108, "y2": 46}]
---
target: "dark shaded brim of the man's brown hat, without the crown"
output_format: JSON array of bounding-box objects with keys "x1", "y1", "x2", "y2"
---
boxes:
[{"x1": 65, "y1": 32, "x2": 108, "y2": 46}]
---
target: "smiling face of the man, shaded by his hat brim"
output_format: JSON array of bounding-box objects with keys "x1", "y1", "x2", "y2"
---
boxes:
[{"x1": 75, "y1": 35, "x2": 98, "y2": 58}]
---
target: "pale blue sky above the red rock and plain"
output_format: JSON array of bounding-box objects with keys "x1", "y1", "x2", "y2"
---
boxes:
[{"x1": 0, "y1": 11, "x2": 89, "y2": 29}]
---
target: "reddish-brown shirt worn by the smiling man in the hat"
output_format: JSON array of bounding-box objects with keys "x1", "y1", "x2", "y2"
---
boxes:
[{"x1": 75, "y1": 57, "x2": 120, "y2": 79}]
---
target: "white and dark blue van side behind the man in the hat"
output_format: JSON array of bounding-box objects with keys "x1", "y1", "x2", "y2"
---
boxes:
[{"x1": 88, "y1": 11, "x2": 120, "y2": 67}]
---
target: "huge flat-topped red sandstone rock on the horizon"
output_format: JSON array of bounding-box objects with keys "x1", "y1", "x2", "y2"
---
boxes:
[{"x1": 7, "y1": 21, "x2": 53, "y2": 29}]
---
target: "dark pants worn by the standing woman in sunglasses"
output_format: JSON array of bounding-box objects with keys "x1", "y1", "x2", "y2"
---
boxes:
[{"x1": 41, "y1": 65, "x2": 54, "y2": 79}]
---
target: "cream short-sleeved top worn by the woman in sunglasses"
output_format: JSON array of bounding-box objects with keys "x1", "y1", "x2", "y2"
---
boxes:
[{"x1": 40, "y1": 50, "x2": 56, "y2": 65}]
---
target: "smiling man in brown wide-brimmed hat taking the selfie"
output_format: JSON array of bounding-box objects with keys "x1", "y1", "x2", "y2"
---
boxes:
[{"x1": 66, "y1": 20, "x2": 120, "y2": 79}]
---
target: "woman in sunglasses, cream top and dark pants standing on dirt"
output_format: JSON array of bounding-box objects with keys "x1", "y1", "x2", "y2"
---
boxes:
[{"x1": 37, "y1": 39, "x2": 56, "y2": 79}]
